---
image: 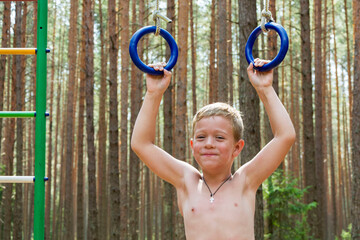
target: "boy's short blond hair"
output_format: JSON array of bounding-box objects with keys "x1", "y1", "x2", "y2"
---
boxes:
[{"x1": 193, "y1": 102, "x2": 244, "y2": 142}]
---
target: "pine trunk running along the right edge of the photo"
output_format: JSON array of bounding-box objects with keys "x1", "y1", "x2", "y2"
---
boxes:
[{"x1": 351, "y1": 0, "x2": 360, "y2": 239}]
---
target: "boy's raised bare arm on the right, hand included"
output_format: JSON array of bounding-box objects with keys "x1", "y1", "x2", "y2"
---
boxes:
[{"x1": 243, "y1": 59, "x2": 296, "y2": 189}]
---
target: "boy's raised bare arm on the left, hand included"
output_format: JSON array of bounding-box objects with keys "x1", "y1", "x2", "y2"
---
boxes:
[{"x1": 131, "y1": 65, "x2": 194, "y2": 188}]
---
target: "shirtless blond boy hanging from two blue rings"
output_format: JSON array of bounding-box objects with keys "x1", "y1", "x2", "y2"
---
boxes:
[{"x1": 131, "y1": 59, "x2": 295, "y2": 240}]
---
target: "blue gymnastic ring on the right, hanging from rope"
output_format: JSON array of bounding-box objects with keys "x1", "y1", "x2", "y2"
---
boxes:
[{"x1": 245, "y1": 22, "x2": 289, "y2": 72}]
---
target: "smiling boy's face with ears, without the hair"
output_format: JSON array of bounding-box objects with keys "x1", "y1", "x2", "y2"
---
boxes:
[{"x1": 190, "y1": 116, "x2": 244, "y2": 171}]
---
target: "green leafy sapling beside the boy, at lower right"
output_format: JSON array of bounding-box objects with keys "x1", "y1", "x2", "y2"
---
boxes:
[{"x1": 263, "y1": 170, "x2": 316, "y2": 240}]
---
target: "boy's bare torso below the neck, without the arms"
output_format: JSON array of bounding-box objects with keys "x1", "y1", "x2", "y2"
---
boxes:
[{"x1": 178, "y1": 172, "x2": 255, "y2": 240}]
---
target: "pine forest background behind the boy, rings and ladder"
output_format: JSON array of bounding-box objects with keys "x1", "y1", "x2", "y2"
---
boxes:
[{"x1": 0, "y1": 0, "x2": 360, "y2": 240}]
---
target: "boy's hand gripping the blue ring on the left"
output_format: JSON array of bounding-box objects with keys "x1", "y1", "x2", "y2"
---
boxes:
[{"x1": 146, "y1": 62, "x2": 171, "y2": 94}]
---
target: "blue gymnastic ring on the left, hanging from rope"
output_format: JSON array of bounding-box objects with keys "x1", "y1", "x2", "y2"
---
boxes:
[{"x1": 129, "y1": 26, "x2": 178, "y2": 75}]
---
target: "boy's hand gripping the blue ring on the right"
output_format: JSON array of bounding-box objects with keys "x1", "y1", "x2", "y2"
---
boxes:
[{"x1": 247, "y1": 58, "x2": 273, "y2": 90}]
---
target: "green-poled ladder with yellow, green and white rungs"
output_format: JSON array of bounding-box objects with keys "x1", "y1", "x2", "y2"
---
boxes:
[{"x1": 0, "y1": 0, "x2": 50, "y2": 240}]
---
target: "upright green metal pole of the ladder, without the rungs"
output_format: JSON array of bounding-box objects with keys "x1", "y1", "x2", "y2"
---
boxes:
[{"x1": 34, "y1": 0, "x2": 48, "y2": 237}]
